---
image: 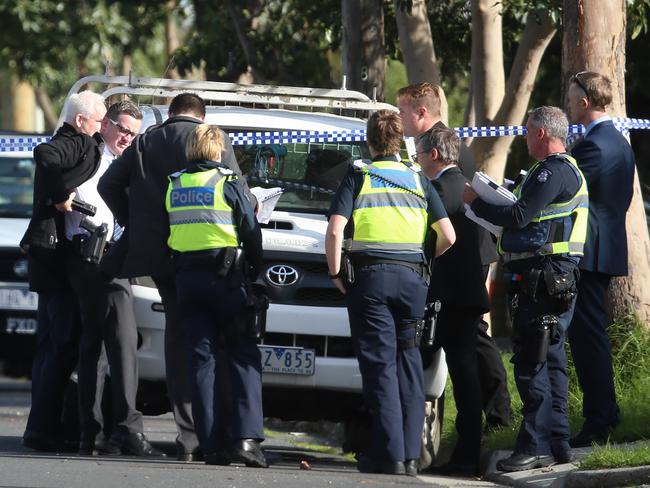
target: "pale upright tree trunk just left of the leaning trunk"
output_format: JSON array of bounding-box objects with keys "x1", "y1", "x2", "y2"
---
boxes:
[{"x1": 472, "y1": 0, "x2": 505, "y2": 124}]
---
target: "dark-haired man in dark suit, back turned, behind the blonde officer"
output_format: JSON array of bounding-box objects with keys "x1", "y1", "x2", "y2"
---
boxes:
[{"x1": 97, "y1": 93, "x2": 256, "y2": 461}]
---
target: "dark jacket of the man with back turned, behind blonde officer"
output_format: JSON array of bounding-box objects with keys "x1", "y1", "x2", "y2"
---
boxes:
[{"x1": 97, "y1": 116, "x2": 256, "y2": 278}]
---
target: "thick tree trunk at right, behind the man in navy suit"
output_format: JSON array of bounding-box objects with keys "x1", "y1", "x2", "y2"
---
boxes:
[{"x1": 562, "y1": 0, "x2": 650, "y2": 324}]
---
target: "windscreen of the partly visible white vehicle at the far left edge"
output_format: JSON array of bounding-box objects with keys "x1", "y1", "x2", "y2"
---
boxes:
[{"x1": 0, "y1": 155, "x2": 35, "y2": 218}]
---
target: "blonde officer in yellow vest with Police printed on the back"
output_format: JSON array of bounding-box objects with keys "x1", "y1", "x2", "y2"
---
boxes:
[{"x1": 165, "y1": 124, "x2": 268, "y2": 468}]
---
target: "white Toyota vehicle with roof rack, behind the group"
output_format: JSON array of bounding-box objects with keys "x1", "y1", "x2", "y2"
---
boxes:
[{"x1": 59, "y1": 76, "x2": 447, "y2": 464}]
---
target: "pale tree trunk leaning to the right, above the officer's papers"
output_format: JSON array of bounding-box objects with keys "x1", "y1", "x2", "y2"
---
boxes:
[{"x1": 470, "y1": 10, "x2": 555, "y2": 181}]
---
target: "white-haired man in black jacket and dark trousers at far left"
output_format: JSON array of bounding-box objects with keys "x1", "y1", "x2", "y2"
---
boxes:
[{"x1": 20, "y1": 91, "x2": 106, "y2": 452}]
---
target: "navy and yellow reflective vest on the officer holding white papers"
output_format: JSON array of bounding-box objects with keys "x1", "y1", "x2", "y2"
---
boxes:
[{"x1": 498, "y1": 154, "x2": 589, "y2": 263}]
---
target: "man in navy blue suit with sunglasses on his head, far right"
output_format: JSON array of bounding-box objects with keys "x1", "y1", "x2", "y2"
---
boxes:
[{"x1": 568, "y1": 72, "x2": 634, "y2": 447}]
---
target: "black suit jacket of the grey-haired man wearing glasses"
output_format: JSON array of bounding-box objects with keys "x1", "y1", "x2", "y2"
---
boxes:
[{"x1": 429, "y1": 167, "x2": 490, "y2": 314}]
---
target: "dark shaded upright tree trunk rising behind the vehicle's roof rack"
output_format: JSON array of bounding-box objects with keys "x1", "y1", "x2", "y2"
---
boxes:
[{"x1": 341, "y1": 0, "x2": 386, "y2": 100}]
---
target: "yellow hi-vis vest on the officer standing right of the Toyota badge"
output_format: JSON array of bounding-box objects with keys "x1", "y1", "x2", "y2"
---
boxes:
[{"x1": 350, "y1": 161, "x2": 427, "y2": 253}]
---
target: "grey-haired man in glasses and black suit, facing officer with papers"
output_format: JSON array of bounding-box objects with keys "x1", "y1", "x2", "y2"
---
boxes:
[{"x1": 416, "y1": 127, "x2": 490, "y2": 476}]
